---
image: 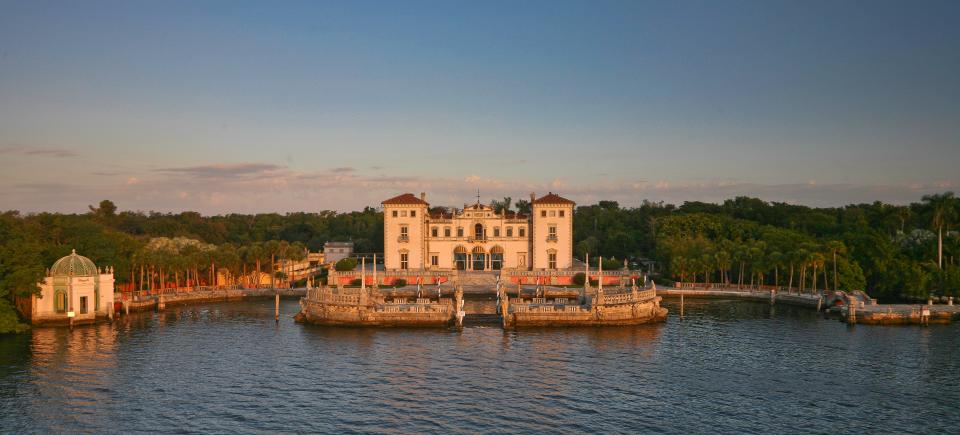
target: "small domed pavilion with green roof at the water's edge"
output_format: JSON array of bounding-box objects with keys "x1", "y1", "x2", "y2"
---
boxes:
[{"x1": 17, "y1": 250, "x2": 113, "y2": 324}]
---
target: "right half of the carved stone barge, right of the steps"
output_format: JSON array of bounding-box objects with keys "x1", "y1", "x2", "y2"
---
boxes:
[{"x1": 500, "y1": 285, "x2": 667, "y2": 328}]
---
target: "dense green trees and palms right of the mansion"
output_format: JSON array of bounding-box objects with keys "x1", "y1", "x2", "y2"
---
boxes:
[{"x1": 574, "y1": 193, "x2": 960, "y2": 301}]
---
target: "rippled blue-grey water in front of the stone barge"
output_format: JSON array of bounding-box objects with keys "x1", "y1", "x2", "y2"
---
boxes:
[{"x1": 0, "y1": 300, "x2": 960, "y2": 433}]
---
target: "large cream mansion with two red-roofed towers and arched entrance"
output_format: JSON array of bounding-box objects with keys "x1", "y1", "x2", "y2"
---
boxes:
[{"x1": 382, "y1": 193, "x2": 575, "y2": 270}]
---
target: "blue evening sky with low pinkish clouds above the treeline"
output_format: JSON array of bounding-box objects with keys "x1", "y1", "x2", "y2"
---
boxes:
[{"x1": 0, "y1": 0, "x2": 960, "y2": 214}]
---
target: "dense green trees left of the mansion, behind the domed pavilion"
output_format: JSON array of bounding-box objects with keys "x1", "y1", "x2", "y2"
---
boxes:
[{"x1": 0, "y1": 201, "x2": 383, "y2": 333}]
